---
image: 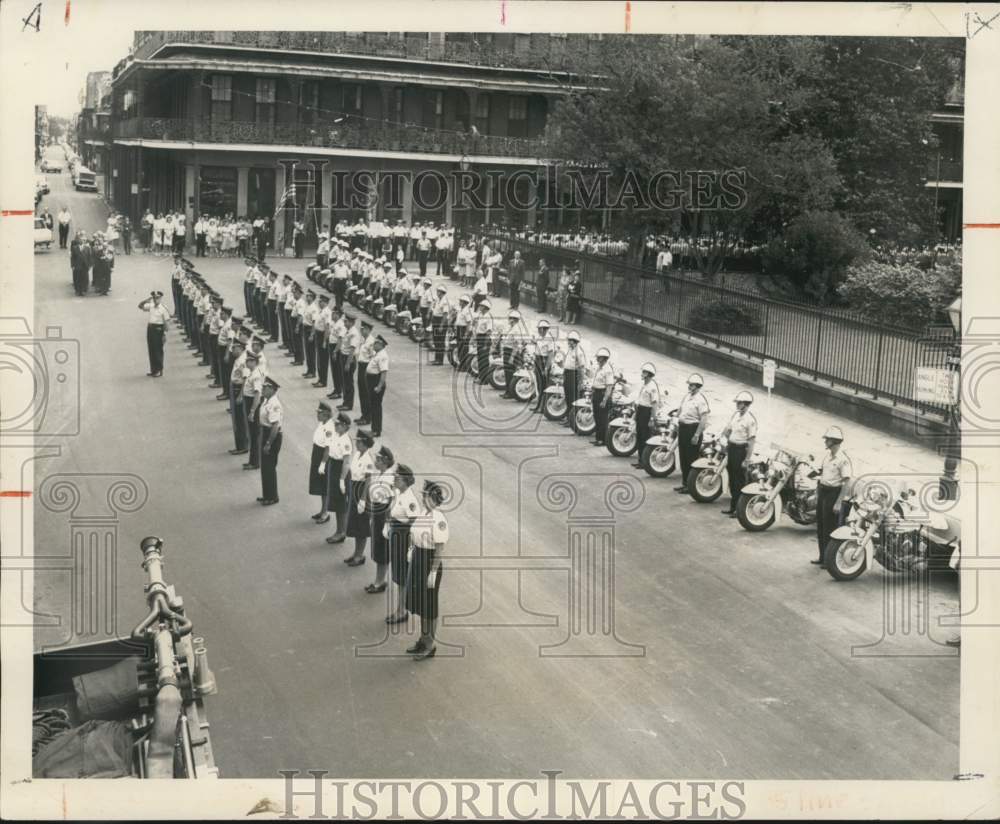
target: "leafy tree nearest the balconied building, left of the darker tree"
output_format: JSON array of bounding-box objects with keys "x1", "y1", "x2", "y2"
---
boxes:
[{"x1": 550, "y1": 37, "x2": 840, "y2": 277}]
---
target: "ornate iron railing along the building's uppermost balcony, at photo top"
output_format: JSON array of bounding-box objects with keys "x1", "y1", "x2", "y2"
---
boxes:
[{"x1": 129, "y1": 31, "x2": 599, "y2": 77}]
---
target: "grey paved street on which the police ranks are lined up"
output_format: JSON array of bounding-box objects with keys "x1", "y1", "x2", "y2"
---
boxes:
[{"x1": 35, "y1": 150, "x2": 959, "y2": 779}]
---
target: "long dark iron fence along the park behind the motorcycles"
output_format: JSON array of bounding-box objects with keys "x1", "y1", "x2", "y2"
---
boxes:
[{"x1": 472, "y1": 234, "x2": 956, "y2": 415}]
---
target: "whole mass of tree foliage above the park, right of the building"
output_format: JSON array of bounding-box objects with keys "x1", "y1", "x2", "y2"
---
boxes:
[{"x1": 548, "y1": 35, "x2": 962, "y2": 273}]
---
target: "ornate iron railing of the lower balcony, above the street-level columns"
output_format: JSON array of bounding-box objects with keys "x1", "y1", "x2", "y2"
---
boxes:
[{"x1": 115, "y1": 117, "x2": 545, "y2": 159}]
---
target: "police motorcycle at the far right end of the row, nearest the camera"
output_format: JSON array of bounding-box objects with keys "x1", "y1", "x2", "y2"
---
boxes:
[{"x1": 823, "y1": 481, "x2": 961, "y2": 581}]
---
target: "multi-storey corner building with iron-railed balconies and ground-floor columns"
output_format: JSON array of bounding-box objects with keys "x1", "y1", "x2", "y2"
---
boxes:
[{"x1": 108, "y1": 31, "x2": 612, "y2": 249}]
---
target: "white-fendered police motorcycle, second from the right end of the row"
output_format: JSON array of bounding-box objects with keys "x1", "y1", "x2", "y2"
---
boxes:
[{"x1": 736, "y1": 444, "x2": 819, "y2": 532}]
